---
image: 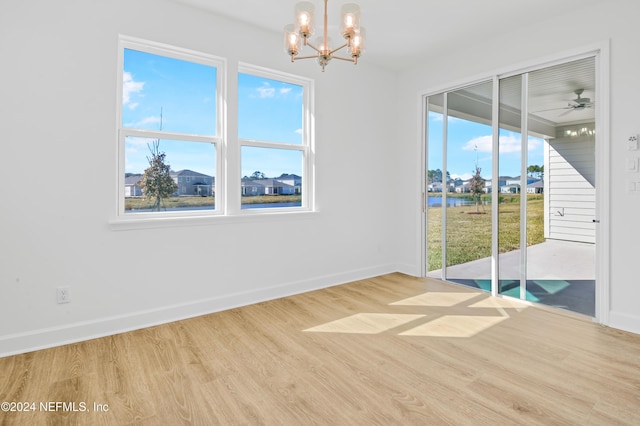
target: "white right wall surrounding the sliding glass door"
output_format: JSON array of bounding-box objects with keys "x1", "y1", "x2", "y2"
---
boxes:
[{"x1": 396, "y1": 0, "x2": 640, "y2": 333}]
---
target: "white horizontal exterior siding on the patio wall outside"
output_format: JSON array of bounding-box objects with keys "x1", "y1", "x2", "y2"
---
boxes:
[{"x1": 545, "y1": 136, "x2": 596, "y2": 243}]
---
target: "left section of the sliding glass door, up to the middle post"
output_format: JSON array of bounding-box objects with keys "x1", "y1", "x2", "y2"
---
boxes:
[{"x1": 426, "y1": 81, "x2": 493, "y2": 290}]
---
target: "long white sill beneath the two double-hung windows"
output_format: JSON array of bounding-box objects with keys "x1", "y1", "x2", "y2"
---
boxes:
[{"x1": 109, "y1": 210, "x2": 319, "y2": 231}]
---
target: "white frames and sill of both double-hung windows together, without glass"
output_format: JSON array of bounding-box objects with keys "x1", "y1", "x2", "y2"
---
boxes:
[{"x1": 109, "y1": 35, "x2": 316, "y2": 230}]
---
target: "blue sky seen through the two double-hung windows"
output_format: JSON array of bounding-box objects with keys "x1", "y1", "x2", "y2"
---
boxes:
[{"x1": 122, "y1": 49, "x2": 303, "y2": 177}]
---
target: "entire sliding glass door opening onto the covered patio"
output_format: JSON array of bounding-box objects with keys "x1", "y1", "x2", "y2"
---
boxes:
[{"x1": 425, "y1": 56, "x2": 596, "y2": 316}]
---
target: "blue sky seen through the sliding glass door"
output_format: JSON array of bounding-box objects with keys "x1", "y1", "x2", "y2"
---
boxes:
[{"x1": 428, "y1": 112, "x2": 544, "y2": 180}]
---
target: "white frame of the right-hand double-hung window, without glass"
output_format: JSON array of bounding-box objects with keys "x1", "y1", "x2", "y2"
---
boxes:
[{"x1": 236, "y1": 63, "x2": 315, "y2": 215}]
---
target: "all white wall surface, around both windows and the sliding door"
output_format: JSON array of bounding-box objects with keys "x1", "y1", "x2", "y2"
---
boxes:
[{"x1": 0, "y1": 0, "x2": 640, "y2": 356}]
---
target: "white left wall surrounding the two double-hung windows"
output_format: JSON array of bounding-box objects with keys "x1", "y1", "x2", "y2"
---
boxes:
[{"x1": 0, "y1": 0, "x2": 398, "y2": 356}]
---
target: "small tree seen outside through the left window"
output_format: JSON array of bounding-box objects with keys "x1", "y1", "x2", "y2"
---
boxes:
[{"x1": 140, "y1": 139, "x2": 178, "y2": 211}]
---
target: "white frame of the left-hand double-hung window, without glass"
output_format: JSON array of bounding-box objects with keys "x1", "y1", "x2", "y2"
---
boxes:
[{"x1": 116, "y1": 35, "x2": 227, "y2": 222}]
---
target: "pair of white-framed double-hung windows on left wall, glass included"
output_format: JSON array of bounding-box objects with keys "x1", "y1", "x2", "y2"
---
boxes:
[{"x1": 115, "y1": 36, "x2": 313, "y2": 226}]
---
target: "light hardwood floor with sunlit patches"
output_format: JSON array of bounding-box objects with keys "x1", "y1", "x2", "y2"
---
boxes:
[{"x1": 0, "y1": 274, "x2": 640, "y2": 425}]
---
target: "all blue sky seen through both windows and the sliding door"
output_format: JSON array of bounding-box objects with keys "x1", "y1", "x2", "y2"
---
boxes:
[{"x1": 122, "y1": 49, "x2": 544, "y2": 179}]
